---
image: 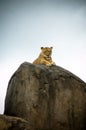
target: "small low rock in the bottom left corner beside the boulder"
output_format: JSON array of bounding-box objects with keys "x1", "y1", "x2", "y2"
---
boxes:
[{"x1": 0, "y1": 115, "x2": 34, "y2": 130}]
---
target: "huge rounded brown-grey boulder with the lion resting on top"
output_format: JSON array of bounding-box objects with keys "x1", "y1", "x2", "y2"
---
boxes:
[{"x1": 4, "y1": 62, "x2": 86, "y2": 130}]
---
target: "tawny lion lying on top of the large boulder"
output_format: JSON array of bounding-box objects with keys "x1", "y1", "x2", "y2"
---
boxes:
[{"x1": 33, "y1": 47, "x2": 55, "y2": 66}]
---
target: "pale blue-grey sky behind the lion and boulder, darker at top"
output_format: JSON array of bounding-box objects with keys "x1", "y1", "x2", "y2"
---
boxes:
[{"x1": 0, "y1": 0, "x2": 86, "y2": 113}]
